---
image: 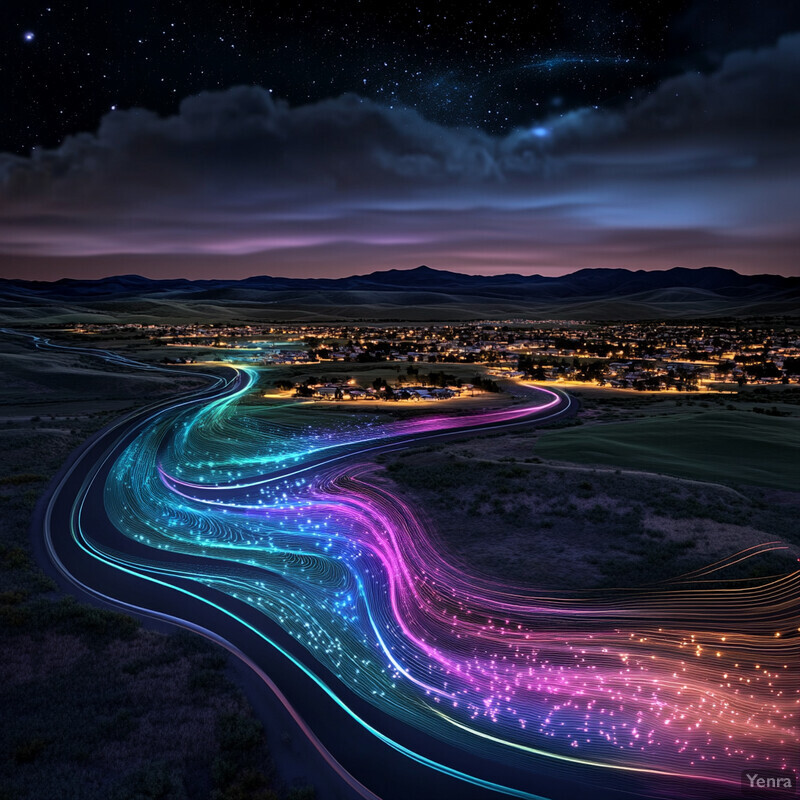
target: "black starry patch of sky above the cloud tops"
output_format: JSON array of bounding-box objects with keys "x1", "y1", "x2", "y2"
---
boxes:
[{"x1": 6, "y1": 0, "x2": 800, "y2": 153}]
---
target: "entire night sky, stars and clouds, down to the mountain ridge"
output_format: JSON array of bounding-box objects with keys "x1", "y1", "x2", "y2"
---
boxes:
[{"x1": 0, "y1": 0, "x2": 800, "y2": 278}]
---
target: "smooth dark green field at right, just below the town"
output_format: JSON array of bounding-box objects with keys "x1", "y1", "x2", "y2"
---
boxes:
[{"x1": 536, "y1": 410, "x2": 800, "y2": 490}]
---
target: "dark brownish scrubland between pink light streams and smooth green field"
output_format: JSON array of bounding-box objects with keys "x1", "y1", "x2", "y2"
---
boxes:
[{"x1": 377, "y1": 434, "x2": 800, "y2": 590}]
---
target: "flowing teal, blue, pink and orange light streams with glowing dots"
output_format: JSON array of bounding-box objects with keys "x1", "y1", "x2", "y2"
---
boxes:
[{"x1": 39, "y1": 330, "x2": 800, "y2": 792}]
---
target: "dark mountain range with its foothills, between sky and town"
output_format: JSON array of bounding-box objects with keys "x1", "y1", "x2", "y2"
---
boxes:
[{"x1": 0, "y1": 266, "x2": 800, "y2": 324}]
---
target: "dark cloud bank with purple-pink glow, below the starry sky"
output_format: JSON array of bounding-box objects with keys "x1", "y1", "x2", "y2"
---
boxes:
[{"x1": 0, "y1": 35, "x2": 800, "y2": 274}]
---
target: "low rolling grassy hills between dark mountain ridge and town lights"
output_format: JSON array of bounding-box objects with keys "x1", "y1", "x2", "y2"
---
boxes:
[{"x1": 0, "y1": 288, "x2": 797, "y2": 325}]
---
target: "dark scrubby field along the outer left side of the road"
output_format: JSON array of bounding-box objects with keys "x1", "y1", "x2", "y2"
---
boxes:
[{"x1": 0, "y1": 337, "x2": 314, "y2": 800}]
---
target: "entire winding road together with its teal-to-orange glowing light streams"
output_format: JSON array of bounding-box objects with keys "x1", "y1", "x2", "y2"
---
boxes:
[{"x1": 17, "y1": 332, "x2": 800, "y2": 800}]
